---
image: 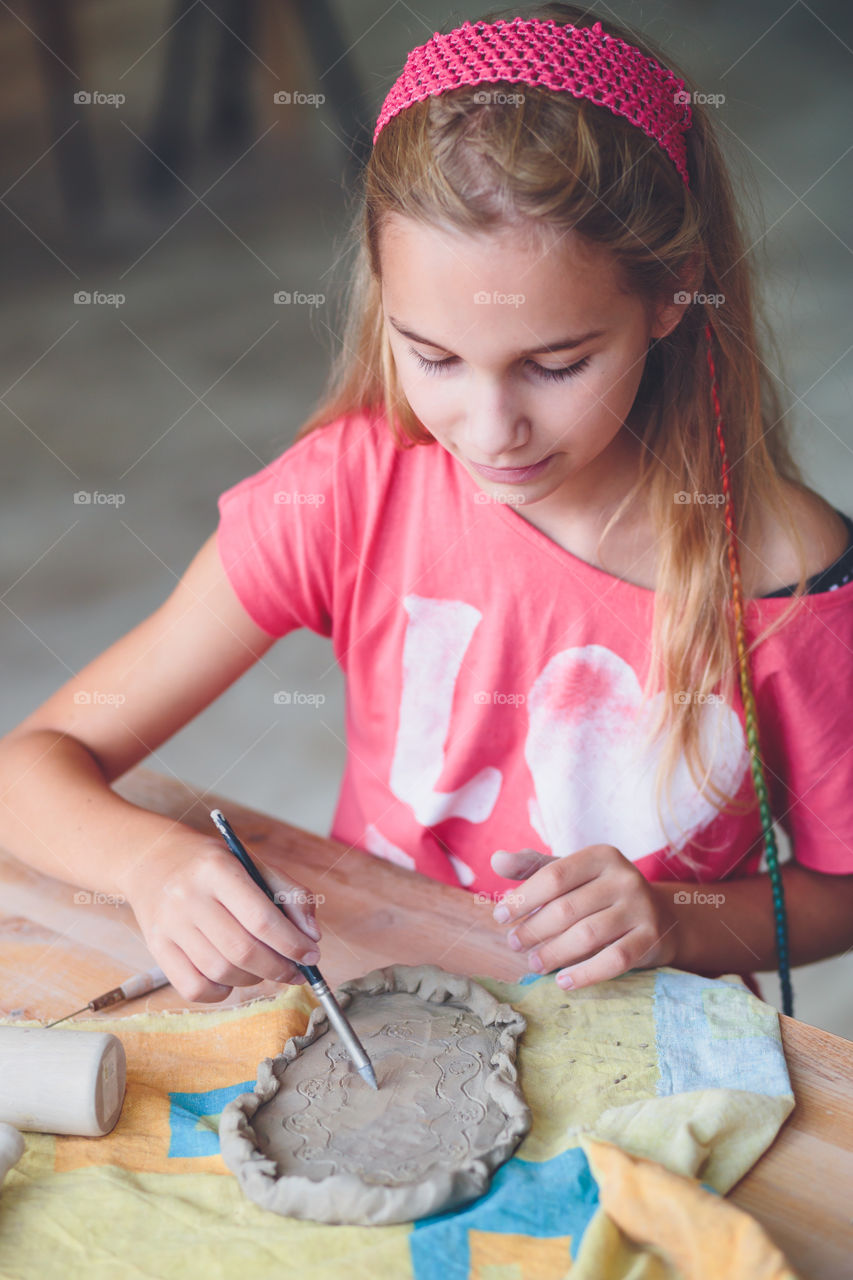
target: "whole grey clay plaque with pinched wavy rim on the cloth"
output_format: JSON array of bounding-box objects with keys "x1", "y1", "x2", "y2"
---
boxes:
[{"x1": 219, "y1": 965, "x2": 530, "y2": 1224}]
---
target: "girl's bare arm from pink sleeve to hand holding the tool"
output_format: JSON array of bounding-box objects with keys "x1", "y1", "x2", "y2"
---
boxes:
[{"x1": 0, "y1": 534, "x2": 319, "y2": 1001}]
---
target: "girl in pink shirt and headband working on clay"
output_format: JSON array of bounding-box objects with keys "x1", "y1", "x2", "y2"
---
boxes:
[{"x1": 0, "y1": 4, "x2": 853, "y2": 1010}]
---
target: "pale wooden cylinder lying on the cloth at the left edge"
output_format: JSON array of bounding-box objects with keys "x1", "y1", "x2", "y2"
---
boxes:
[{"x1": 0, "y1": 1027, "x2": 127, "y2": 1138}]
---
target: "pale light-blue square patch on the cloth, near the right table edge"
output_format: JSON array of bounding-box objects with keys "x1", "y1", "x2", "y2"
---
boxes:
[{"x1": 654, "y1": 973, "x2": 792, "y2": 1097}]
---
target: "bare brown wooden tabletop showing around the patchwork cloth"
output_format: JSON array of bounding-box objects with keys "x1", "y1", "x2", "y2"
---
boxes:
[{"x1": 0, "y1": 768, "x2": 853, "y2": 1280}]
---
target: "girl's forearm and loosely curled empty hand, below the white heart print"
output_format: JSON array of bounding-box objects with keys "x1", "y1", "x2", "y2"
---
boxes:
[{"x1": 492, "y1": 845, "x2": 853, "y2": 987}]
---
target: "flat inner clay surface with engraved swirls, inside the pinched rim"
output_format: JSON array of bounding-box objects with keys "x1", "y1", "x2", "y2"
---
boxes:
[{"x1": 254, "y1": 992, "x2": 506, "y2": 1185}]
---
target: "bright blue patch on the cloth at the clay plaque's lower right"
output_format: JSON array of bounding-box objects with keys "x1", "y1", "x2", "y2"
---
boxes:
[{"x1": 409, "y1": 1147, "x2": 598, "y2": 1280}]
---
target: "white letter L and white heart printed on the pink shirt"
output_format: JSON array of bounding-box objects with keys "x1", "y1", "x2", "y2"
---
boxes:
[{"x1": 377, "y1": 595, "x2": 749, "y2": 861}]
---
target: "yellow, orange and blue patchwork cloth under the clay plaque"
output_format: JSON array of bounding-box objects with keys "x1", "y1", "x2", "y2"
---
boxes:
[{"x1": 0, "y1": 969, "x2": 795, "y2": 1280}]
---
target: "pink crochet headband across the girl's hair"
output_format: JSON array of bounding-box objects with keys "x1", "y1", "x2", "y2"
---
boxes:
[{"x1": 373, "y1": 18, "x2": 692, "y2": 186}]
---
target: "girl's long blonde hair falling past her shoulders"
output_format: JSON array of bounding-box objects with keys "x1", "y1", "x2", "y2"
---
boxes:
[{"x1": 297, "y1": 4, "x2": 831, "y2": 867}]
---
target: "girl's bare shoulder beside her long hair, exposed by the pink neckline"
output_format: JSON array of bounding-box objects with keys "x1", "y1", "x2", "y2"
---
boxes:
[{"x1": 739, "y1": 481, "x2": 850, "y2": 598}]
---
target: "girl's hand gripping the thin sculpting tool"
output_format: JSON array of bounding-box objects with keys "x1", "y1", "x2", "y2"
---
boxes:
[{"x1": 123, "y1": 835, "x2": 320, "y2": 1001}]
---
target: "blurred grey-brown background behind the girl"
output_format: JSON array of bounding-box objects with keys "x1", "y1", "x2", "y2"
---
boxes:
[{"x1": 0, "y1": 0, "x2": 853, "y2": 1038}]
